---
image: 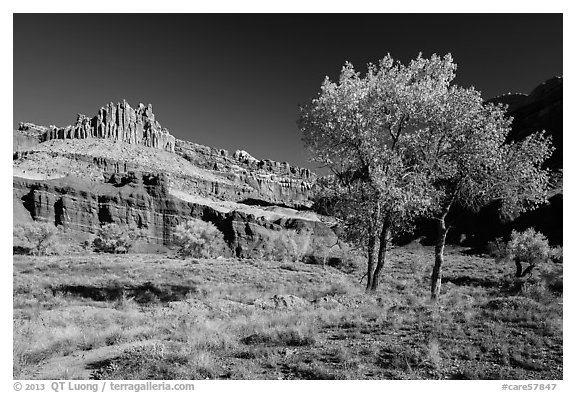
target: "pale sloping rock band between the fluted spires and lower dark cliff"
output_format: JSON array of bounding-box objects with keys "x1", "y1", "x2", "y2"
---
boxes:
[{"x1": 13, "y1": 140, "x2": 312, "y2": 206}]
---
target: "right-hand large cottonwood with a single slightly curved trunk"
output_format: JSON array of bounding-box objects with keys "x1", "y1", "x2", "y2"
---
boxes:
[{"x1": 407, "y1": 86, "x2": 553, "y2": 299}]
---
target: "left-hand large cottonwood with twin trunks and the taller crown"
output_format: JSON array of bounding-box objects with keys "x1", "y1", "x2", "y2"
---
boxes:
[{"x1": 298, "y1": 55, "x2": 455, "y2": 290}]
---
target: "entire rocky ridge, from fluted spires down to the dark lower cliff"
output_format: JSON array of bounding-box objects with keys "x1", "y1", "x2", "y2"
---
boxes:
[{"x1": 13, "y1": 101, "x2": 326, "y2": 257}]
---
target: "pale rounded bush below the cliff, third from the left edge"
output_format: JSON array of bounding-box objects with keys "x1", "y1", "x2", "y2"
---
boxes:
[{"x1": 174, "y1": 219, "x2": 226, "y2": 258}]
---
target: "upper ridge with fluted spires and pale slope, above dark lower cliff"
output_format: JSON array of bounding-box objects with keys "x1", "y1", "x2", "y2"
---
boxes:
[{"x1": 13, "y1": 101, "x2": 315, "y2": 206}]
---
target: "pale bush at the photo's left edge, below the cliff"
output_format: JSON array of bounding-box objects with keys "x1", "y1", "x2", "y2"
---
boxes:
[{"x1": 13, "y1": 222, "x2": 58, "y2": 255}]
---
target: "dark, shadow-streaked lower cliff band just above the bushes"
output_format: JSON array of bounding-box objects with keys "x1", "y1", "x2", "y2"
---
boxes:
[{"x1": 13, "y1": 172, "x2": 336, "y2": 258}]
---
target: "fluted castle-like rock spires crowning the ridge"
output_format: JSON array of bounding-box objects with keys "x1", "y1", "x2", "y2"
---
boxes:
[{"x1": 19, "y1": 100, "x2": 176, "y2": 152}]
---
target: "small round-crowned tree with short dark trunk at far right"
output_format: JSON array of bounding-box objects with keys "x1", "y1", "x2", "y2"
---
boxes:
[{"x1": 506, "y1": 228, "x2": 550, "y2": 278}]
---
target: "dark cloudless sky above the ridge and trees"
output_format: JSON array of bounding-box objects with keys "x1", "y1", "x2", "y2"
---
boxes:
[{"x1": 13, "y1": 14, "x2": 562, "y2": 170}]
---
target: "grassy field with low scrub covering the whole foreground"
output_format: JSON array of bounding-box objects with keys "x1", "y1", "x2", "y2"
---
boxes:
[{"x1": 14, "y1": 246, "x2": 563, "y2": 379}]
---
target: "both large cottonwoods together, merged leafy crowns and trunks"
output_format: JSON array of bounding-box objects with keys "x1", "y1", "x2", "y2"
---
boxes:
[{"x1": 298, "y1": 55, "x2": 553, "y2": 297}]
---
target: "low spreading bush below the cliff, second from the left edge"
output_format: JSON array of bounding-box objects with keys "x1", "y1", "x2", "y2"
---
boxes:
[{"x1": 92, "y1": 223, "x2": 144, "y2": 254}]
